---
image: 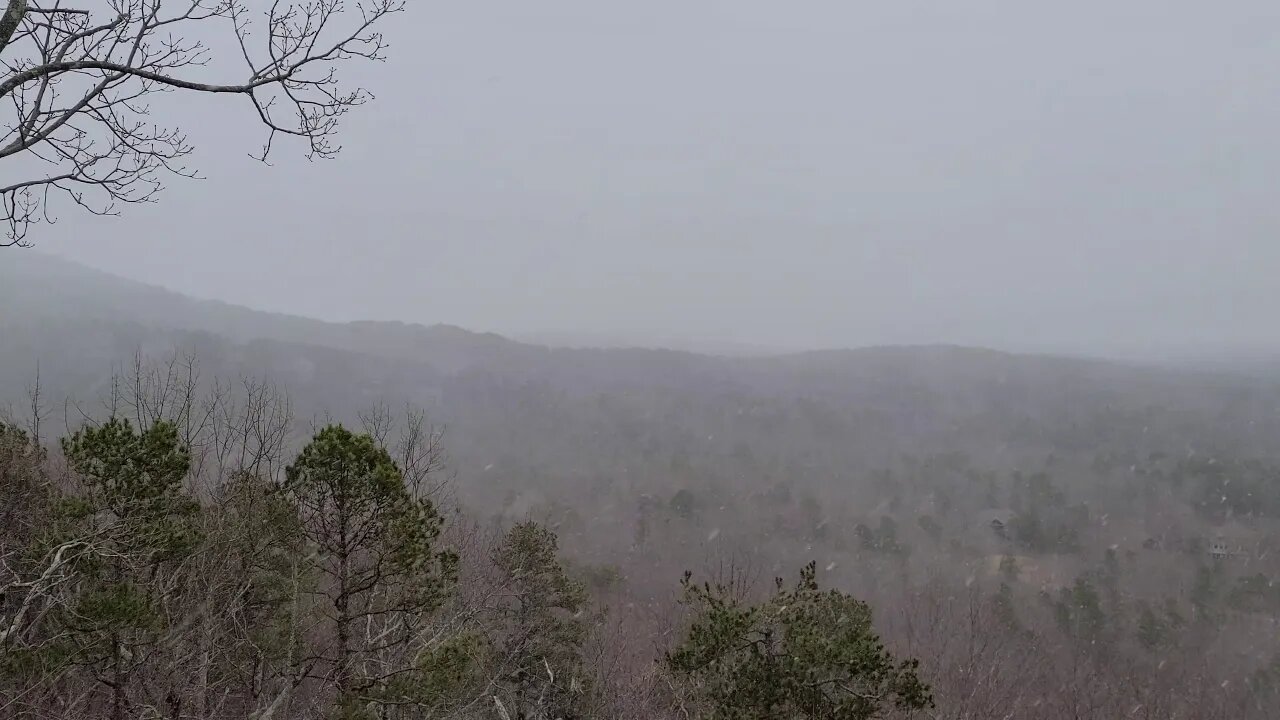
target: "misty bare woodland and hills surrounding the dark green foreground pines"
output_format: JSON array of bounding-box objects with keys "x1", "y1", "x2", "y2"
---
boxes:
[{"x1": 0, "y1": 250, "x2": 1280, "y2": 719}]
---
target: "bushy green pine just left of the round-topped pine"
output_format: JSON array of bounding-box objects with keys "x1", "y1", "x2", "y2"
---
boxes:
[{"x1": 49, "y1": 418, "x2": 200, "y2": 720}]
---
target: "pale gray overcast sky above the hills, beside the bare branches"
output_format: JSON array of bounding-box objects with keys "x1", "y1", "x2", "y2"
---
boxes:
[{"x1": 35, "y1": 0, "x2": 1280, "y2": 352}]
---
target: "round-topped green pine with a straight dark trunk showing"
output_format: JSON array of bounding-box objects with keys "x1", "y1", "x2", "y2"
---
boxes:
[{"x1": 284, "y1": 425, "x2": 457, "y2": 715}]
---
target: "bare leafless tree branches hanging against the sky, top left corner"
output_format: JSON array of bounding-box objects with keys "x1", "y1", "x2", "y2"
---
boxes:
[{"x1": 0, "y1": 0, "x2": 404, "y2": 247}]
